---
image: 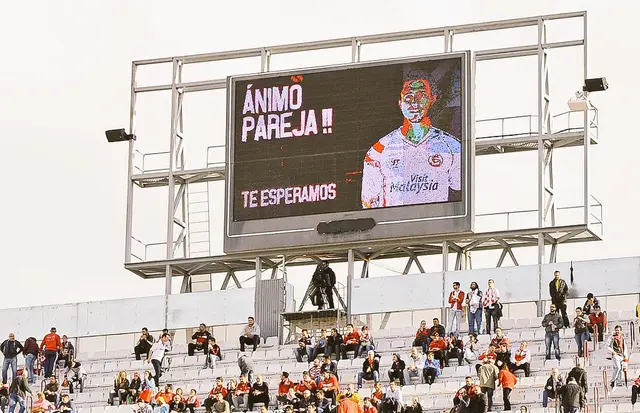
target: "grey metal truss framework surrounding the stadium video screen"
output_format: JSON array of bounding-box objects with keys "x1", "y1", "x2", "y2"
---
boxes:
[{"x1": 125, "y1": 12, "x2": 602, "y2": 307}]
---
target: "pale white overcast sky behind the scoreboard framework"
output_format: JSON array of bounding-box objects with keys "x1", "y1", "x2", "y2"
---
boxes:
[{"x1": 0, "y1": 0, "x2": 640, "y2": 307}]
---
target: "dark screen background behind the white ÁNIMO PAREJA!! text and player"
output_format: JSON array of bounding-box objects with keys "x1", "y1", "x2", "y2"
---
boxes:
[{"x1": 230, "y1": 58, "x2": 466, "y2": 221}]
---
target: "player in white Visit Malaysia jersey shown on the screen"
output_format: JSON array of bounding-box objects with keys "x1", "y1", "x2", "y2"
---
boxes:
[{"x1": 361, "y1": 71, "x2": 461, "y2": 209}]
